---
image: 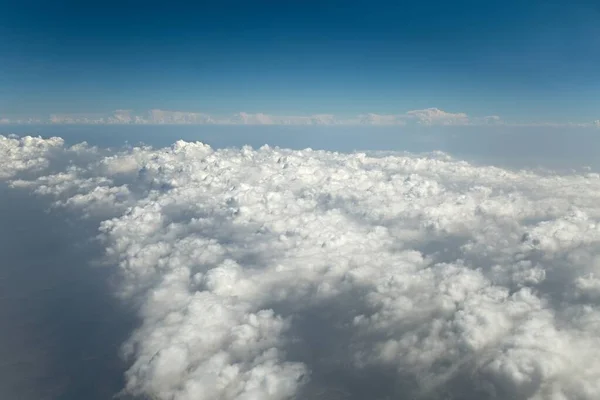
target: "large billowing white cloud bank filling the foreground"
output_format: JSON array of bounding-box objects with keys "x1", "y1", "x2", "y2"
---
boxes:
[{"x1": 5, "y1": 137, "x2": 600, "y2": 400}]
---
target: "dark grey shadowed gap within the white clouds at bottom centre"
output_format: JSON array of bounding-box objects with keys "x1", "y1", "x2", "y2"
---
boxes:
[{"x1": 271, "y1": 287, "x2": 504, "y2": 400}]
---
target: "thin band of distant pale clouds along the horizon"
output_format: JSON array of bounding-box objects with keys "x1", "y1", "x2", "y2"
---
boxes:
[{"x1": 0, "y1": 107, "x2": 600, "y2": 128}]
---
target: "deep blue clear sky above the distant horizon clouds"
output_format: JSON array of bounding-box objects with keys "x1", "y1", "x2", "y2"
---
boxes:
[{"x1": 0, "y1": 0, "x2": 600, "y2": 122}]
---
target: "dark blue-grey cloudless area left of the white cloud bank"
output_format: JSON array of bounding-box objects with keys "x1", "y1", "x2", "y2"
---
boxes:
[{"x1": 0, "y1": 185, "x2": 136, "y2": 400}]
